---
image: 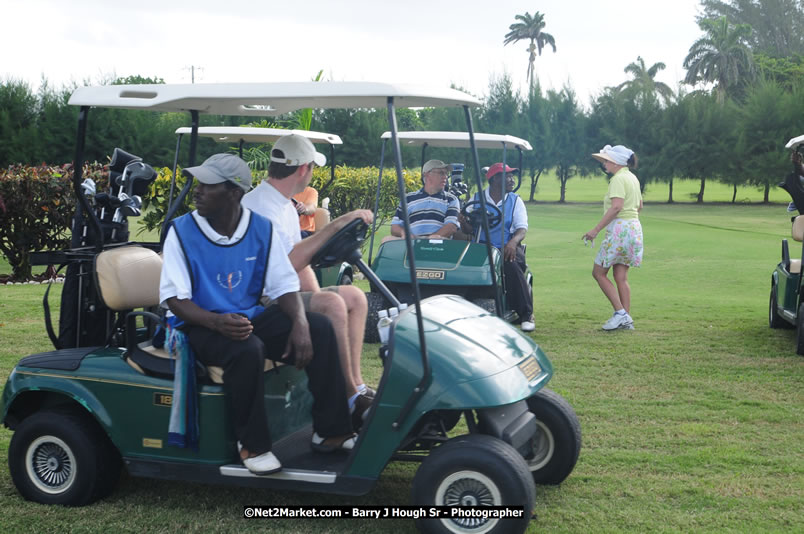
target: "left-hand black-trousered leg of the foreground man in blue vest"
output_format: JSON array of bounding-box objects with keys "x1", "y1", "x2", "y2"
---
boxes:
[{"x1": 186, "y1": 326, "x2": 271, "y2": 455}]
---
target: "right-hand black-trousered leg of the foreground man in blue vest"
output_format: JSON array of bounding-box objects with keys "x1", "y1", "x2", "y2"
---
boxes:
[{"x1": 252, "y1": 306, "x2": 352, "y2": 438}]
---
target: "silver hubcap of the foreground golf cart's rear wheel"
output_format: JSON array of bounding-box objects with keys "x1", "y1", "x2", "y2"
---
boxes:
[{"x1": 25, "y1": 436, "x2": 76, "y2": 494}]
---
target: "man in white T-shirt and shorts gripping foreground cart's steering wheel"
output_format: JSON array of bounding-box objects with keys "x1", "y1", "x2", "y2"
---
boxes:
[{"x1": 242, "y1": 134, "x2": 374, "y2": 430}]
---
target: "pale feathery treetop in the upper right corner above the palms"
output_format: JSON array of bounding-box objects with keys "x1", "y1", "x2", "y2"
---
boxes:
[{"x1": 700, "y1": 0, "x2": 804, "y2": 58}]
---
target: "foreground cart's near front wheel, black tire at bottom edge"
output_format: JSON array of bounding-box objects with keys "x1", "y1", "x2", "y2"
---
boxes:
[{"x1": 411, "y1": 434, "x2": 536, "y2": 534}]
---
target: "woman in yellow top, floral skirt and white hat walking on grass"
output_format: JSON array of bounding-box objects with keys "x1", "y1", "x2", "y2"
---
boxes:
[{"x1": 583, "y1": 145, "x2": 642, "y2": 330}]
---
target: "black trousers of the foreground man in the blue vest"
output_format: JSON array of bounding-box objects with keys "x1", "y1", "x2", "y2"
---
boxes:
[{"x1": 190, "y1": 306, "x2": 352, "y2": 454}]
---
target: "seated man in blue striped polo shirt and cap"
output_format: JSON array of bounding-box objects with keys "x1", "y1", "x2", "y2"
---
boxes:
[{"x1": 391, "y1": 159, "x2": 460, "y2": 239}]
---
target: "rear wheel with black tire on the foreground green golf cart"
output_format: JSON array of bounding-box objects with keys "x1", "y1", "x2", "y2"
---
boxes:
[{"x1": 8, "y1": 411, "x2": 122, "y2": 506}]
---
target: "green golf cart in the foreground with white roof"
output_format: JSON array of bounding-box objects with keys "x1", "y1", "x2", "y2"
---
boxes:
[{"x1": 0, "y1": 82, "x2": 581, "y2": 533}]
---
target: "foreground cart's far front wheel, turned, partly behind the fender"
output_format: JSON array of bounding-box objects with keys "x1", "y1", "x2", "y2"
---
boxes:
[{"x1": 525, "y1": 388, "x2": 581, "y2": 484}]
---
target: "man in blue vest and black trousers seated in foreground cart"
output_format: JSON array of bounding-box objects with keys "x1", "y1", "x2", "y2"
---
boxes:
[{"x1": 159, "y1": 154, "x2": 354, "y2": 475}]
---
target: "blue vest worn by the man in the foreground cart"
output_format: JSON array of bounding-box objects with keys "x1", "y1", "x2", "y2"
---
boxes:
[{"x1": 172, "y1": 212, "x2": 272, "y2": 326}]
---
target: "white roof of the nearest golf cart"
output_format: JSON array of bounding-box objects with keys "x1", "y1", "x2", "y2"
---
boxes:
[{"x1": 69, "y1": 82, "x2": 480, "y2": 116}]
